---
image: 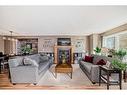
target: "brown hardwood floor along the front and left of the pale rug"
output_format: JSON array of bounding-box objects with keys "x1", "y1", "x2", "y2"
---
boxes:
[{"x1": 0, "y1": 68, "x2": 127, "y2": 90}]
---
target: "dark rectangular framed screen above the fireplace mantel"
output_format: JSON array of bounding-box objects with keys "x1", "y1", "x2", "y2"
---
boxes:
[{"x1": 57, "y1": 38, "x2": 71, "y2": 46}]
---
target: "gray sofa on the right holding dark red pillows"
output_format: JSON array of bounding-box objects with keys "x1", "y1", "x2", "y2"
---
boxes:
[{"x1": 79, "y1": 55, "x2": 112, "y2": 84}]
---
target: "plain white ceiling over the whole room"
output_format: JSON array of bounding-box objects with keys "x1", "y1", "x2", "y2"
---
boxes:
[{"x1": 0, "y1": 6, "x2": 127, "y2": 36}]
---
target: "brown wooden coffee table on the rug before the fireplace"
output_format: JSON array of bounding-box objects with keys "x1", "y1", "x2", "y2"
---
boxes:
[{"x1": 55, "y1": 63, "x2": 73, "y2": 79}]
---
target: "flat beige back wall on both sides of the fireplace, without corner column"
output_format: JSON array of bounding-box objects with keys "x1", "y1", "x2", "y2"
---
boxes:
[{"x1": 38, "y1": 36, "x2": 89, "y2": 52}]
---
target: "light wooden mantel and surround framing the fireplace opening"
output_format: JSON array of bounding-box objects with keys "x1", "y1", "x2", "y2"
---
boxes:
[{"x1": 54, "y1": 45, "x2": 74, "y2": 64}]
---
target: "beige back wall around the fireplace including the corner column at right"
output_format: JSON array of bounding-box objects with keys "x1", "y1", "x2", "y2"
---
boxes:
[{"x1": 14, "y1": 34, "x2": 100, "y2": 53}]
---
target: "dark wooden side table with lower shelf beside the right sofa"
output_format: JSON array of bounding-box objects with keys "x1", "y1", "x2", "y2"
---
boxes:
[{"x1": 99, "y1": 66, "x2": 122, "y2": 89}]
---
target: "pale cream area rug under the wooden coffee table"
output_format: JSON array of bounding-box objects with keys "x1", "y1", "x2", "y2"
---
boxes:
[{"x1": 37, "y1": 64, "x2": 99, "y2": 87}]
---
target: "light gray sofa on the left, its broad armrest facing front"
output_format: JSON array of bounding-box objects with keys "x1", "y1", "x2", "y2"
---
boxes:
[{"x1": 9, "y1": 54, "x2": 53, "y2": 85}]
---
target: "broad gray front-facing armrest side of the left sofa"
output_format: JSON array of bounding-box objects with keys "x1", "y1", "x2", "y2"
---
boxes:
[{"x1": 10, "y1": 66, "x2": 38, "y2": 83}]
